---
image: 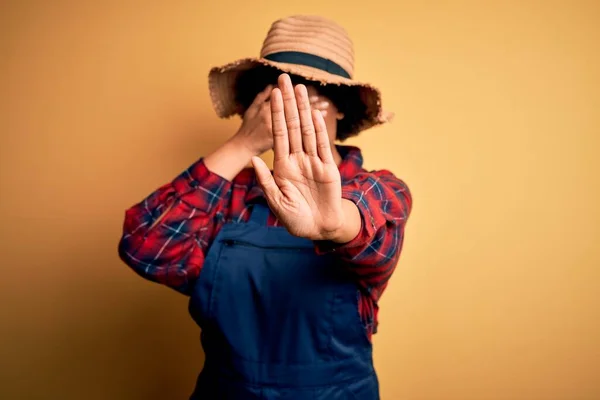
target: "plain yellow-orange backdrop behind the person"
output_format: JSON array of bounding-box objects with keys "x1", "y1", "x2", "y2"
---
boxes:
[{"x1": 0, "y1": 0, "x2": 600, "y2": 400}]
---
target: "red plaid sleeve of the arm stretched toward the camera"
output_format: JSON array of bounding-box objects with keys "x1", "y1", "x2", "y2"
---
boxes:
[{"x1": 315, "y1": 170, "x2": 412, "y2": 300}]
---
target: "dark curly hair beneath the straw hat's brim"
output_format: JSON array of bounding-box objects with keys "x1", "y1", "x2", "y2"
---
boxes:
[{"x1": 235, "y1": 66, "x2": 367, "y2": 142}]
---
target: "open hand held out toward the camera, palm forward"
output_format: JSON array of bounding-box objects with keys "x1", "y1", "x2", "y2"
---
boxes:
[{"x1": 252, "y1": 74, "x2": 346, "y2": 240}]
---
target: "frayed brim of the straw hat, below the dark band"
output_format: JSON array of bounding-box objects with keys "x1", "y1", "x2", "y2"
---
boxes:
[{"x1": 208, "y1": 58, "x2": 394, "y2": 133}]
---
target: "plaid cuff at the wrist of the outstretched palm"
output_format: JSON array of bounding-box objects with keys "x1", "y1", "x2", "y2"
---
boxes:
[{"x1": 314, "y1": 189, "x2": 377, "y2": 256}]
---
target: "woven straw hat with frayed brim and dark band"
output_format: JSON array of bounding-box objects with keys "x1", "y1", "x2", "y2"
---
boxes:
[{"x1": 208, "y1": 15, "x2": 393, "y2": 134}]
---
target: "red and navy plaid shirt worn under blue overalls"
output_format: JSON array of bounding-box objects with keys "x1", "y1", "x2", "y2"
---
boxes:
[{"x1": 119, "y1": 146, "x2": 412, "y2": 337}]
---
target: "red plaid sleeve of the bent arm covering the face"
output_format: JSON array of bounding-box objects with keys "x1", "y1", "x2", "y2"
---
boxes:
[{"x1": 118, "y1": 159, "x2": 231, "y2": 294}]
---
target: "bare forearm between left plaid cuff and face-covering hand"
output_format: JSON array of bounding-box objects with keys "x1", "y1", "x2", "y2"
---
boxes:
[{"x1": 204, "y1": 135, "x2": 256, "y2": 181}]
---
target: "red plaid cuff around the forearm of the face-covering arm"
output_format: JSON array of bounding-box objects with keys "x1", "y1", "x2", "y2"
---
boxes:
[{"x1": 173, "y1": 158, "x2": 232, "y2": 212}]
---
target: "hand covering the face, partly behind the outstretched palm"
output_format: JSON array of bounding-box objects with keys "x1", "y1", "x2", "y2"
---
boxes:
[{"x1": 231, "y1": 85, "x2": 273, "y2": 156}]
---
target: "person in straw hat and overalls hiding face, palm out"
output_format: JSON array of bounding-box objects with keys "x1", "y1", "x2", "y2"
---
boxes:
[{"x1": 119, "y1": 16, "x2": 412, "y2": 400}]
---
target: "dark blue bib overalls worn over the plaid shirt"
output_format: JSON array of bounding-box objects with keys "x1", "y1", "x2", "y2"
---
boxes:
[{"x1": 189, "y1": 203, "x2": 379, "y2": 400}]
